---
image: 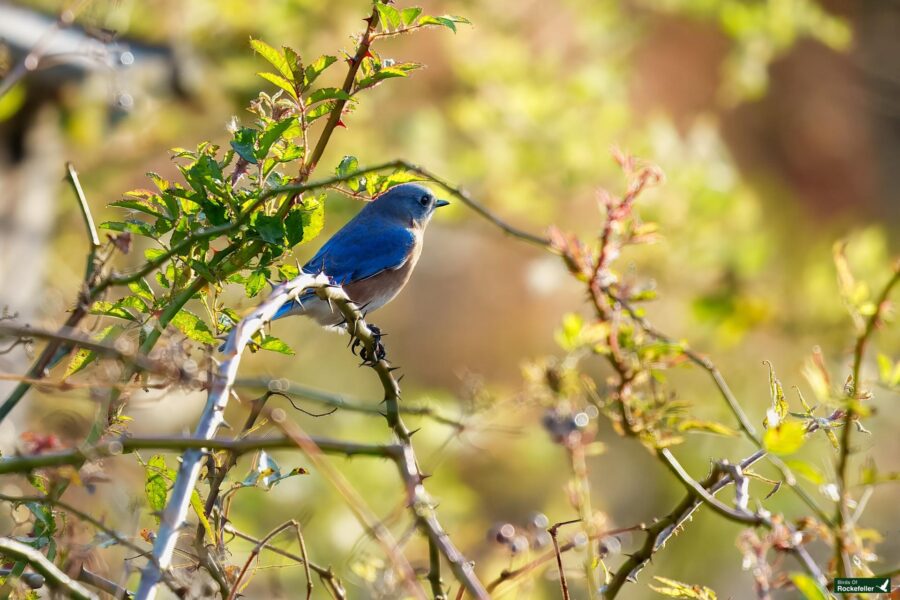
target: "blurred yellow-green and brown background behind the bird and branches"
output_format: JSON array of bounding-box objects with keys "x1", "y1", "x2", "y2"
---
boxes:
[{"x1": 0, "y1": 0, "x2": 900, "y2": 599}]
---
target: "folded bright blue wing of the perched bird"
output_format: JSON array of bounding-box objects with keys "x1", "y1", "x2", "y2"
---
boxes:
[{"x1": 303, "y1": 222, "x2": 416, "y2": 285}]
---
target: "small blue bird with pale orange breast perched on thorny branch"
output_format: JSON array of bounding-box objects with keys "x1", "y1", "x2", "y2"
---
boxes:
[{"x1": 274, "y1": 183, "x2": 450, "y2": 327}]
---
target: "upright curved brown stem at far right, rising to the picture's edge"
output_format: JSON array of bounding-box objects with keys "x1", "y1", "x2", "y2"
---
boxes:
[{"x1": 834, "y1": 261, "x2": 900, "y2": 577}]
